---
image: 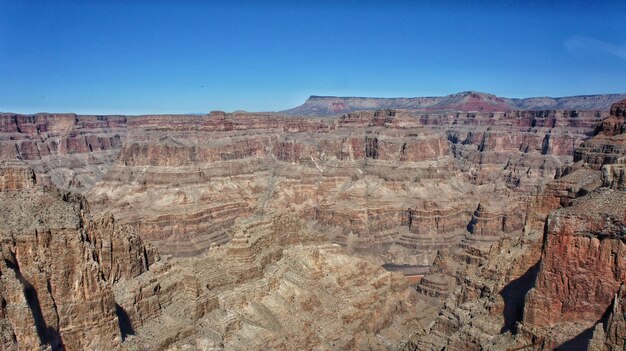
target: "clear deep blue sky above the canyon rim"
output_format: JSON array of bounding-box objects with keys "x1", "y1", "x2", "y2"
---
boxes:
[{"x1": 0, "y1": 0, "x2": 626, "y2": 114}]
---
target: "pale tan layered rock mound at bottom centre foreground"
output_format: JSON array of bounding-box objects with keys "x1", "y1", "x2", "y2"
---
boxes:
[{"x1": 115, "y1": 214, "x2": 422, "y2": 350}]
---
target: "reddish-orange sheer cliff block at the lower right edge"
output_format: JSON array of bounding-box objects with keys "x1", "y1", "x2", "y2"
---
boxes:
[{"x1": 524, "y1": 189, "x2": 626, "y2": 346}]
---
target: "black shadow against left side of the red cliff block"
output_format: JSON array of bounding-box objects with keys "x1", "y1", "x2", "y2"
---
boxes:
[{"x1": 500, "y1": 261, "x2": 539, "y2": 333}]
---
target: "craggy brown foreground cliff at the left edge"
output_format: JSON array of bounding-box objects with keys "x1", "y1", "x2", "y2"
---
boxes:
[{"x1": 0, "y1": 163, "x2": 157, "y2": 350}]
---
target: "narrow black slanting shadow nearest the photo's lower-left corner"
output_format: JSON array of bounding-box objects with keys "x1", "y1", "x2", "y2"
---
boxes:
[{"x1": 4, "y1": 260, "x2": 65, "y2": 351}]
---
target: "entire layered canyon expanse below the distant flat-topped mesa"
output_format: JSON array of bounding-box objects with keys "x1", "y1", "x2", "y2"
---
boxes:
[{"x1": 0, "y1": 97, "x2": 626, "y2": 350}]
